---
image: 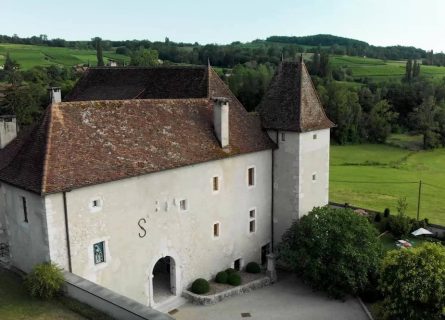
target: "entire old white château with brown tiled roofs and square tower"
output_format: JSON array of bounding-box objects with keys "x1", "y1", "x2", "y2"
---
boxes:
[{"x1": 0, "y1": 61, "x2": 333, "y2": 307}]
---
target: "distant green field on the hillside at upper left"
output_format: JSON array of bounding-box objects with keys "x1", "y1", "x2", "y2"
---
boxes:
[{"x1": 0, "y1": 43, "x2": 130, "y2": 70}]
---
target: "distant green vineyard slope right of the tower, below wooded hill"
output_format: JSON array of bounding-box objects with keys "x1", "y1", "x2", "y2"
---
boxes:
[{"x1": 331, "y1": 56, "x2": 445, "y2": 81}]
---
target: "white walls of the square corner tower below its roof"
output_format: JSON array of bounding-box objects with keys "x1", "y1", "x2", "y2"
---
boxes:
[{"x1": 268, "y1": 129, "x2": 329, "y2": 244}]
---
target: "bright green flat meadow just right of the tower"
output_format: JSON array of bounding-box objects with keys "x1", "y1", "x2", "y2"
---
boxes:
[{"x1": 330, "y1": 137, "x2": 445, "y2": 225}]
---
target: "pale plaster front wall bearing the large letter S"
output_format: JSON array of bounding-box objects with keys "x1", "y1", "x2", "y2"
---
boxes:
[{"x1": 46, "y1": 150, "x2": 272, "y2": 304}]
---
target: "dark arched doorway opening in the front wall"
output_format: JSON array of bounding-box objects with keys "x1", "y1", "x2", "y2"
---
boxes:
[{"x1": 152, "y1": 256, "x2": 176, "y2": 304}]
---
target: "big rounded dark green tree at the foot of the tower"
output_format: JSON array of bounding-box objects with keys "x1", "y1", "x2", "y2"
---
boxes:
[{"x1": 278, "y1": 207, "x2": 382, "y2": 298}]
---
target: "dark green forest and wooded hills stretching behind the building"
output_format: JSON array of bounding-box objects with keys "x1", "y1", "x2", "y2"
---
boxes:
[{"x1": 0, "y1": 35, "x2": 445, "y2": 149}]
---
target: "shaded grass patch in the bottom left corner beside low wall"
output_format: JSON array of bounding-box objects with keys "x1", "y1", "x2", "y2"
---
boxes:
[{"x1": 0, "y1": 268, "x2": 85, "y2": 320}]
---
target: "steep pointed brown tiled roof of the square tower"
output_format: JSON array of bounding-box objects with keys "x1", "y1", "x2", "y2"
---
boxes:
[{"x1": 257, "y1": 61, "x2": 334, "y2": 132}]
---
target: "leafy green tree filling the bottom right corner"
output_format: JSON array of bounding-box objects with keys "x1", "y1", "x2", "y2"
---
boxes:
[{"x1": 380, "y1": 243, "x2": 445, "y2": 320}]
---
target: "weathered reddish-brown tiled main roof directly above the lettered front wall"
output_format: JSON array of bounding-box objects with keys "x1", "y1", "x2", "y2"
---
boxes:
[{"x1": 0, "y1": 66, "x2": 274, "y2": 194}]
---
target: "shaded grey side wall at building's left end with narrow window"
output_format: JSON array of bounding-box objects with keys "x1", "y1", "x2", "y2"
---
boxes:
[{"x1": 0, "y1": 183, "x2": 50, "y2": 272}]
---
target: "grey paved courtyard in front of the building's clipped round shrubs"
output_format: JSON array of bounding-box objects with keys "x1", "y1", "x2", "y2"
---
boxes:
[{"x1": 173, "y1": 274, "x2": 368, "y2": 320}]
